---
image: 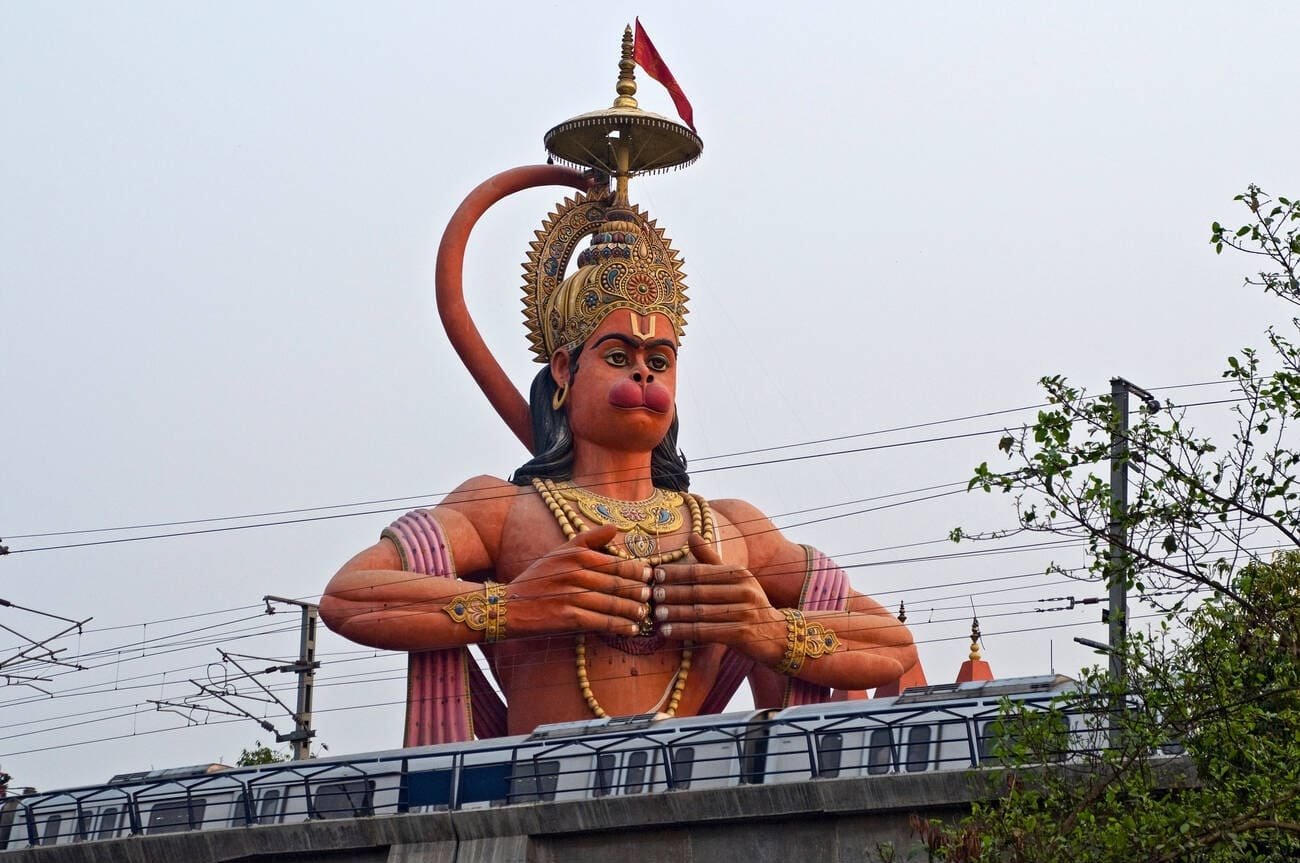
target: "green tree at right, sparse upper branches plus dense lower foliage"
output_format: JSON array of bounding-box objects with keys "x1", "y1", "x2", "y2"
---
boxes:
[{"x1": 918, "y1": 186, "x2": 1300, "y2": 863}]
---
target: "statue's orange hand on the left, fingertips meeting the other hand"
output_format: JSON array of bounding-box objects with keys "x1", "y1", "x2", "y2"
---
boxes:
[{"x1": 507, "y1": 525, "x2": 653, "y2": 637}]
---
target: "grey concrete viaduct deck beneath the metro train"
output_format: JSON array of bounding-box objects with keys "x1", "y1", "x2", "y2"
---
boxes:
[{"x1": 0, "y1": 771, "x2": 997, "y2": 863}]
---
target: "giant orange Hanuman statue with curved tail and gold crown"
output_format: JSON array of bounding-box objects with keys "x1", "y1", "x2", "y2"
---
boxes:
[{"x1": 320, "y1": 31, "x2": 917, "y2": 745}]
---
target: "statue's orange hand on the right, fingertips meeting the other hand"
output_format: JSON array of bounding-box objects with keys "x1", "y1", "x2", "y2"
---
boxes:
[{"x1": 653, "y1": 535, "x2": 785, "y2": 654}]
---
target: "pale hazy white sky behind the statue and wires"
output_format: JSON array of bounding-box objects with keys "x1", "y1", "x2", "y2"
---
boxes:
[{"x1": 0, "y1": 3, "x2": 1300, "y2": 788}]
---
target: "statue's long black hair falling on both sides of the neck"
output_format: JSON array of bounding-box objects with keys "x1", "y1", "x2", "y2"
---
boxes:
[{"x1": 510, "y1": 347, "x2": 690, "y2": 491}]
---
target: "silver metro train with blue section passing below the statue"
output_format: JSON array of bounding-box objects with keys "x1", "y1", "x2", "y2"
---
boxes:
[{"x1": 0, "y1": 676, "x2": 1105, "y2": 851}]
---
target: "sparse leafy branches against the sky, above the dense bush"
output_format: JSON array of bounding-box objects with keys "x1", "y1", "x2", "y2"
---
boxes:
[{"x1": 954, "y1": 186, "x2": 1300, "y2": 615}]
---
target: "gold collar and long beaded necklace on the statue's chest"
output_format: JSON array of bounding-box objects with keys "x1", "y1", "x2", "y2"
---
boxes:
[{"x1": 533, "y1": 478, "x2": 714, "y2": 719}]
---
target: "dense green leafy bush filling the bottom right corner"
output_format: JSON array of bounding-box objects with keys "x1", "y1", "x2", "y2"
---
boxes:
[{"x1": 918, "y1": 552, "x2": 1300, "y2": 863}]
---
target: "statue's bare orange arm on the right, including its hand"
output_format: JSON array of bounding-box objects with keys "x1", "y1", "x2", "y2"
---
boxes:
[{"x1": 655, "y1": 500, "x2": 917, "y2": 689}]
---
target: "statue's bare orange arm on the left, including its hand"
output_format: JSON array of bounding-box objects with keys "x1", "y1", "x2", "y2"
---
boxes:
[{"x1": 320, "y1": 477, "x2": 649, "y2": 650}]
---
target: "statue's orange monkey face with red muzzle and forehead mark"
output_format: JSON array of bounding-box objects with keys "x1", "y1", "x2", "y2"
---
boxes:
[{"x1": 551, "y1": 309, "x2": 677, "y2": 452}]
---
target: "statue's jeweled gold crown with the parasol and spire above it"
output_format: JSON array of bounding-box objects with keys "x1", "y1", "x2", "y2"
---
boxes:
[{"x1": 524, "y1": 27, "x2": 703, "y2": 363}]
